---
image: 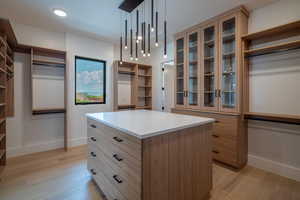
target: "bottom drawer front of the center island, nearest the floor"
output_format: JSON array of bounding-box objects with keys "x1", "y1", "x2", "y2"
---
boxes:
[{"x1": 88, "y1": 159, "x2": 129, "y2": 200}]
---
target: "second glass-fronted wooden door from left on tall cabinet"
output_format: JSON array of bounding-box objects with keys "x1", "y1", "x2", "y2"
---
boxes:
[{"x1": 186, "y1": 31, "x2": 200, "y2": 108}]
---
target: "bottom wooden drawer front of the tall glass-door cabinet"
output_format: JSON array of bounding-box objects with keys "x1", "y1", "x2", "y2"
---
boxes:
[{"x1": 212, "y1": 146, "x2": 237, "y2": 166}]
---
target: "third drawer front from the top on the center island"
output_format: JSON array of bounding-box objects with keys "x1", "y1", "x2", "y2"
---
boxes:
[{"x1": 91, "y1": 145, "x2": 141, "y2": 200}]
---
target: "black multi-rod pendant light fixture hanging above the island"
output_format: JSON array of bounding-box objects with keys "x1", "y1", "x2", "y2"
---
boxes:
[{"x1": 119, "y1": 0, "x2": 168, "y2": 59}]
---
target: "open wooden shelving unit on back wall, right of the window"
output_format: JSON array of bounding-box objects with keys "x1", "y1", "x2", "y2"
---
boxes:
[{"x1": 114, "y1": 61, "x2": 152, "y2": 111}]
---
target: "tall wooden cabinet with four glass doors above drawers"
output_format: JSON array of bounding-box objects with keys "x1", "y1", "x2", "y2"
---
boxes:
[{"x1": 173, "y1": 6, "x2": 248, "y2": 168}]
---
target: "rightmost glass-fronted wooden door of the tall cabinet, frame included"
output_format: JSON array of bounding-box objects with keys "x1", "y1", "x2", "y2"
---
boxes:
[{"x1": 220, "y1": 15, "x2": 238, "y2": 112}]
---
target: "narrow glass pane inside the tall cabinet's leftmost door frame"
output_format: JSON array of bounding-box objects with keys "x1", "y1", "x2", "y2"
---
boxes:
[{"x1": 176, "y1": 38, "x2": 184, "y2": 105}]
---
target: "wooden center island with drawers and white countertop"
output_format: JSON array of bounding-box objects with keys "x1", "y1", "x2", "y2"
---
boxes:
[{"x1": 87, "y1": 110, "x2": 214, "y2": 200}]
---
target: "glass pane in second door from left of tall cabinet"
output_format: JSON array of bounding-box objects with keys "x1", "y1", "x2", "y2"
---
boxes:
[{"x1": 188, "y1": 32, "x2": 198, "y2": 105}]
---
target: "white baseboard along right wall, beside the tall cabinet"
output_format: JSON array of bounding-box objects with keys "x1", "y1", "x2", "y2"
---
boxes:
[{"x1": 248, "y1": 154, "x2": 300, "y2": 182}]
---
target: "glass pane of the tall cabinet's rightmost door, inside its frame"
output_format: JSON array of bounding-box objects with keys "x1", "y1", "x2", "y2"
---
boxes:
[{"x1": 221, "y1": 18, "x2": 236, "y2": 108}]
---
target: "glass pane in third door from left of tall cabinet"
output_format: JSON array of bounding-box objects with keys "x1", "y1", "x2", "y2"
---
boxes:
[{"x1": 204, "y1": 26, "x2": 216, "y2": 107}]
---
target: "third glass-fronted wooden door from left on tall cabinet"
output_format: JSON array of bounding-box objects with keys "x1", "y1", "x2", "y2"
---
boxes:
[{"x1": 201, "y1": 24, "x2": 219, "y2": 111}]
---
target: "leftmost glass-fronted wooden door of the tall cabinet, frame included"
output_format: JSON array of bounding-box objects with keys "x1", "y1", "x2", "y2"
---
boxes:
[{"x1": 175, "y1": 36, "x2": 186, "y2": 107}]
